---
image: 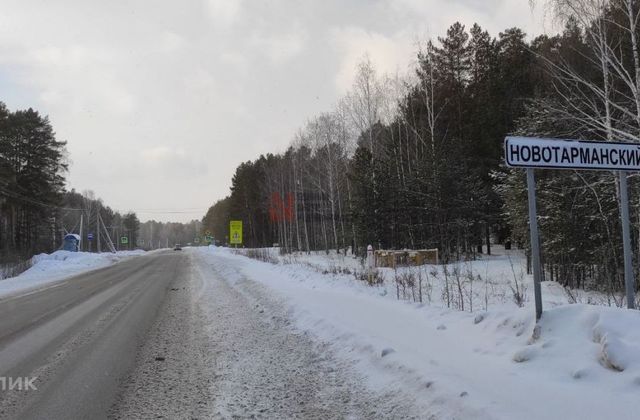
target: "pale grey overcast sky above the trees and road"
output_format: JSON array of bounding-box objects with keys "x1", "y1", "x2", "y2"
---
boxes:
[{"x1": 0, "y1": 0, "x2": 544, "y2": 221}]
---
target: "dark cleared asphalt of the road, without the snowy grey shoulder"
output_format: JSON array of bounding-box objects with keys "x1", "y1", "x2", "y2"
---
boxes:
[{"x1": 0, "y1": 252, "x2": 188, "y2": 419}]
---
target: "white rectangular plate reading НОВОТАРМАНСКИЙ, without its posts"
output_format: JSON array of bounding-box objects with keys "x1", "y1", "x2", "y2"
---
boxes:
[{"x1": 504, "y1": 137, "x2": 640, "y2": 172}]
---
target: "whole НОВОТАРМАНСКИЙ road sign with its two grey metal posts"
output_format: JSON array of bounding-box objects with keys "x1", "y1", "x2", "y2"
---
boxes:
[{"x1": 504, "y1": 137, "x2": 640, "y2": 319}]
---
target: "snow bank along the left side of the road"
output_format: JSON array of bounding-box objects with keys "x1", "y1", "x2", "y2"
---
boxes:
[{"x1": 0, "y1": 250, "x2": 144, "y2": 297}]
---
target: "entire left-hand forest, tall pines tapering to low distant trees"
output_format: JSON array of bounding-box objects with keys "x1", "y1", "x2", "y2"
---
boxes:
[{"x1": 0, "y1": 102, "x2": 200, "y2": 274}]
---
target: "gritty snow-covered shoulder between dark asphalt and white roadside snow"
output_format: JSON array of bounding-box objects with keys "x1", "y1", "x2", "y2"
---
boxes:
[{"x1": 113, "y1": 248, "x2": 429, "y2": 419}]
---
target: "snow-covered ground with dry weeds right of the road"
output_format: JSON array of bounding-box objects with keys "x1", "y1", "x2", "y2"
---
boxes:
[{"x1": 199, "y1": 248, "x2": 640, "y2": 420}]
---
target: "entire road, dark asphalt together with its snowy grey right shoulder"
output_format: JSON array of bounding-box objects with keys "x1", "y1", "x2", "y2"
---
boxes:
[{"x1": 0, "y1": 250, "x2": 430, "y2": 420}]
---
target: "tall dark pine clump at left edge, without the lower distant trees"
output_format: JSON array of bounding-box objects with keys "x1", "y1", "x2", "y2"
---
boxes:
[{"x1": 0, "y1": 102, "x2": 67, "y2": 257}]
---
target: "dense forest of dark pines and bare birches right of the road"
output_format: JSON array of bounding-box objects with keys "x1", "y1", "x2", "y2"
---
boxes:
[{"x1": 203, "y1": 0, "x2": 640, "y2": 300}]
